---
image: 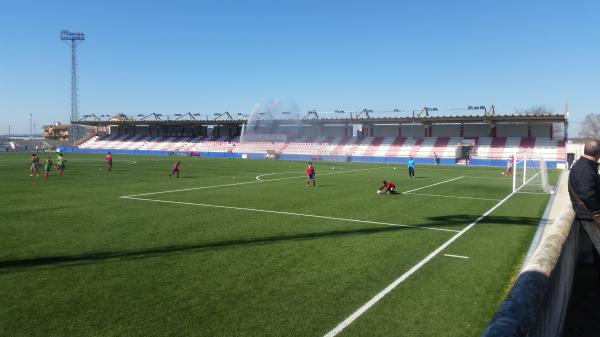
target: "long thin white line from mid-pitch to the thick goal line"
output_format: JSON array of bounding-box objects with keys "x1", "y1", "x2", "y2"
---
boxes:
[{"x1": 121, "y1": 197, "x2": 459, "y2": 233}]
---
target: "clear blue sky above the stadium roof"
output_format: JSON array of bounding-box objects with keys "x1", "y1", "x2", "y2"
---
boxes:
[{"x1": 0, "y1": 0, "x2": 600, "y2": 134}]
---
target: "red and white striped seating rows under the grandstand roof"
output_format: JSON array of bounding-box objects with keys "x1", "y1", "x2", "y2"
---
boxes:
[{"x1": 79, "y1": 135, "x2": 566, "y2": 165}]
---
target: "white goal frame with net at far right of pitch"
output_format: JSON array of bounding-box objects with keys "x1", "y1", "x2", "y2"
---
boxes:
[{"x1": 507, "y1": 152, "x2": 553, "y2": 194}]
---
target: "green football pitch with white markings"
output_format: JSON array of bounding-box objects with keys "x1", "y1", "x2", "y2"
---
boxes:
[{"x1": 0, "y1": 153, "x2": 558, "y2": 336}]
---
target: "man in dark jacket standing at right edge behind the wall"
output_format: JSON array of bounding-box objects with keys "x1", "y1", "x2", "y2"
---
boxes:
[{"x1": 569, "y1": 140, "x2": 600, "y2": 272}]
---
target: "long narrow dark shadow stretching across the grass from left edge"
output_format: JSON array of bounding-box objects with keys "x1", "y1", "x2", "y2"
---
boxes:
[{"x1": 0, "y1": 214, "x2": 539, "y2": 274}]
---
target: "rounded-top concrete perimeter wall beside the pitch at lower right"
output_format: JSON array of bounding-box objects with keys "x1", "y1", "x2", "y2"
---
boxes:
[{"x1": 482, "y1": 205, "x2": 582, "y2": 337}]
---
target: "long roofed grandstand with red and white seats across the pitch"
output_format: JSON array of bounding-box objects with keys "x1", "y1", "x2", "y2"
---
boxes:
[{"x1": 66, "y1": 110, "x2": 568, "y2": 168}]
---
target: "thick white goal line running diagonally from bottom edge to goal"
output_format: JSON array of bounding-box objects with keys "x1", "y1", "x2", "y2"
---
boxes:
[{"x1": 324, "y1": 172, "x2": 539, "y2": 337}]
